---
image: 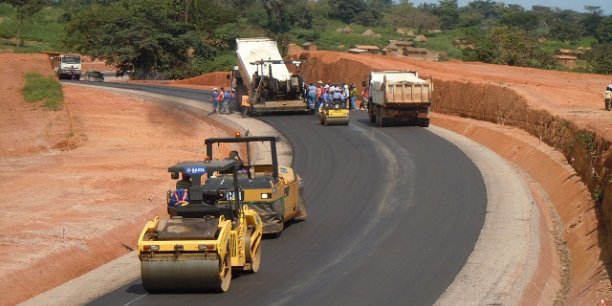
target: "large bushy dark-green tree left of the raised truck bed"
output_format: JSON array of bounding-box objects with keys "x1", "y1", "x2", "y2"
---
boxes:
[{"x1": 64, "y1": 0, "x2": 215, "y2": 78}]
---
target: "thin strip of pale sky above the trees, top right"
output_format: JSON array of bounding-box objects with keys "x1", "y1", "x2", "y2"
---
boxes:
[{"x1": 410, "y1": 0, "x2": 612, "y2": 15}]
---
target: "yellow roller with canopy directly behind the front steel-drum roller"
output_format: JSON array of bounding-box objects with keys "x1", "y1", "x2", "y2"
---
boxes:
[{"x1": 203, "y1": 135, "x2": 307, "y2": 236}]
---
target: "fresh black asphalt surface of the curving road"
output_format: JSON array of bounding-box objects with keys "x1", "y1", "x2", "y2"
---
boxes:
[{"x1": 77, "y1": 83, "x2": 487, "y2": 305}]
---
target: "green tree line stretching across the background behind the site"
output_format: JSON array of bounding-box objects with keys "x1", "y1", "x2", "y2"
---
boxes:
[{"x1": 8, "y1": 0, "x2": 612, "y2": 78}]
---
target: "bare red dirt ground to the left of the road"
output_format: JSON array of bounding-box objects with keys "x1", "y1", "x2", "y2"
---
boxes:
[{"x1": 0, "y1": 54, "x2": 232, "y2": 305}]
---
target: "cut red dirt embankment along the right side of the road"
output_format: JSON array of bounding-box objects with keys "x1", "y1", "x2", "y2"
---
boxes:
[{"x1": 299, "y1": 51, "x2": 612, "y2": 305}]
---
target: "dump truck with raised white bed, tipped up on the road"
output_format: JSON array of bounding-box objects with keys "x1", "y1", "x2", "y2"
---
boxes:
[{"x1": 230, "y1": 37, "x2": 314, "y2": 117}]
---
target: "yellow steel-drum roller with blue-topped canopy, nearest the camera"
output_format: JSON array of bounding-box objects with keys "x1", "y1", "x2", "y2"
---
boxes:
[{"x1": 138, "y1": 160, "x2": 262, "y2": 293}]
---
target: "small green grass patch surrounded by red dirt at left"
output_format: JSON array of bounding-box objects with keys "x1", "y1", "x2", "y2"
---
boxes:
[{"x1": 23, "y1": 72, "x2": 64, "y2": 110}]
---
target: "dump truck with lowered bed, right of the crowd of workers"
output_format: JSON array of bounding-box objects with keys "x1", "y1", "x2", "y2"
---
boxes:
[{"x1": 364, "y1": 71, "x2": 433, "y2": 127}]
